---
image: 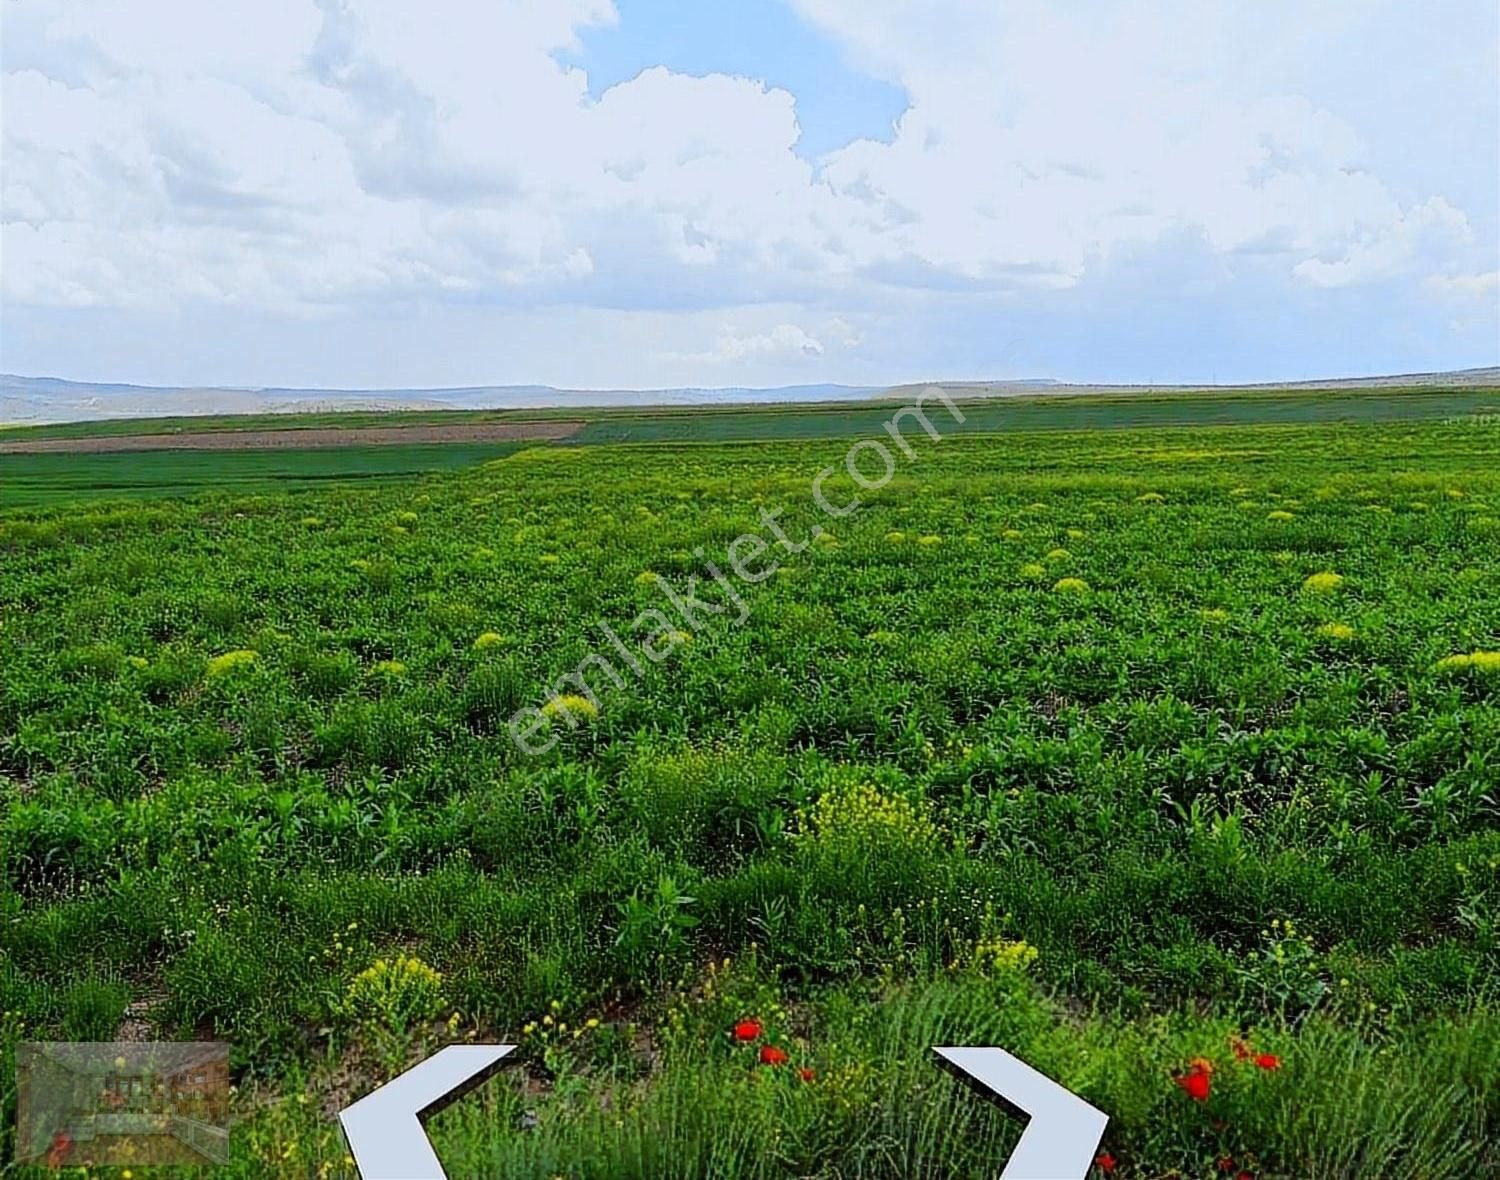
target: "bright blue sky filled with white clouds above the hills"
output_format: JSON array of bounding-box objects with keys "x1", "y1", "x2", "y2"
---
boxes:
[{"x1": 0, "y1": 0, "x2": 1500, "y2": 388}]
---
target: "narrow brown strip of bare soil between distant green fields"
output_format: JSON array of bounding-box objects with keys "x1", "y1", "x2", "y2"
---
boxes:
[{"x1": 0, "y1": 421, "x2": 584, "y2": 454}]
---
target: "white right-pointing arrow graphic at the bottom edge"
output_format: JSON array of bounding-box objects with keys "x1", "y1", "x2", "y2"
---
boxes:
[{"x1": 933, "y1": 1047, "x2": 1110, "y2": 1180}]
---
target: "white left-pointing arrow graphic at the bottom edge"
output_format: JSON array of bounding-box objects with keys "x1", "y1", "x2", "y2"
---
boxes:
[{"x1": 339, "y1": 1045, "x2": 516, "y2": 1180}]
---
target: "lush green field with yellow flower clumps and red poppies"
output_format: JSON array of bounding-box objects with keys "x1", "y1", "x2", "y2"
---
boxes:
[{"x1": 0, "y1": 410, "x2": 1500, "y2": 1180}]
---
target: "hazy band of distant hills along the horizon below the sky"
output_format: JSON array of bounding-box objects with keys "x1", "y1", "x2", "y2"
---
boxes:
[{"x1": 0, "y1": 367, "x2": 1500, "y2": 426}]
